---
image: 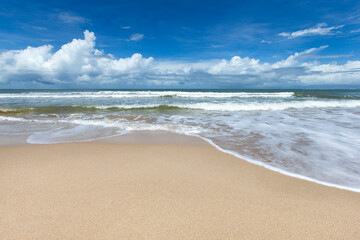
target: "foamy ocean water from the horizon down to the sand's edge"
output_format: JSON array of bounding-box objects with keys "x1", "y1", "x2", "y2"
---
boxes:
[{"x1": 0, "y1": 89, "x2": 360, "y2": 191}]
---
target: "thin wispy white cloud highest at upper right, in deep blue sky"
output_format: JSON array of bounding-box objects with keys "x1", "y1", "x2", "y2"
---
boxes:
[{"x1": 279, "y1": 23, "x2": 344, "y2": 39}]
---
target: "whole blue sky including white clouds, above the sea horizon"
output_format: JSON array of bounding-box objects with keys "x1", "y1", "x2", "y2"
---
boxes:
[{"x1": 0, "y1": 0, "x2": 360, "y2": 88}]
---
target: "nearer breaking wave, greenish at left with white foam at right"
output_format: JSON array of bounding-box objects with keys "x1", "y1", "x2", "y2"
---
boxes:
[{"x1": 0, "y1": 100, "x2": 360, "y2": 115}]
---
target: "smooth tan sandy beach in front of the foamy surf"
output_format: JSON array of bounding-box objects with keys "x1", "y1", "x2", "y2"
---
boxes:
[{"x1": 0, "y1": 134, "x2": 360, "y2": 239}]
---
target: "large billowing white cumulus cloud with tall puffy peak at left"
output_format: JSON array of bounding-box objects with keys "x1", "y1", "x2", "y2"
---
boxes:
[{"x1": 0, "y1": 31, "x2": 153, "y2": 84}]
